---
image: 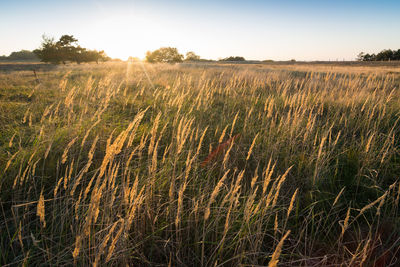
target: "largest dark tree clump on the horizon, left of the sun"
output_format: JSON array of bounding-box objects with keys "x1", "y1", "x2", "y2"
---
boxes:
[{"x1": 33, "y1": 35, "x2": 109, "y2": 64}]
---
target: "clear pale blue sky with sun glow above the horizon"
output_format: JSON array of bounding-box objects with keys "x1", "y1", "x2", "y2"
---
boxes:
[{"x1": 0, "y1": 0, "x2": 400, "y2": 61}]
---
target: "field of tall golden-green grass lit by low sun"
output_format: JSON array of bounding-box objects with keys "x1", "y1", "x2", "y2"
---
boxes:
[{"x1": 0, "y1": 62, "x2": 400, "y2": 266}]
